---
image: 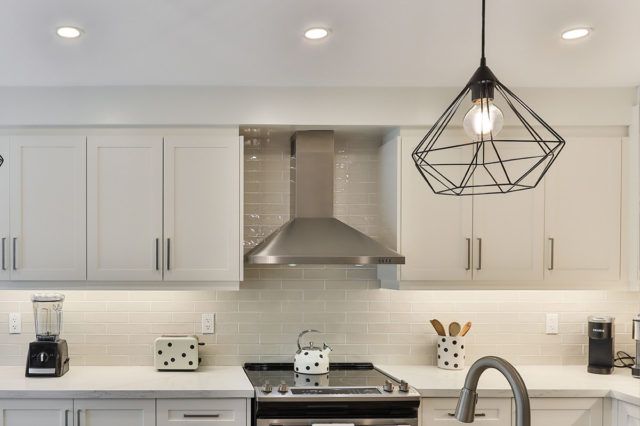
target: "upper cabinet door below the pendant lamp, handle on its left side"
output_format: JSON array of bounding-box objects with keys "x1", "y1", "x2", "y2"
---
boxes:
[{"x1": 473, "y1": 183, "x2": 544, "y2": 281}]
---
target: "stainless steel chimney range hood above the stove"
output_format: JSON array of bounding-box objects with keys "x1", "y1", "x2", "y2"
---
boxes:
[{"x1": 245, "y1": 130, "x2": 404, "y2": 265}]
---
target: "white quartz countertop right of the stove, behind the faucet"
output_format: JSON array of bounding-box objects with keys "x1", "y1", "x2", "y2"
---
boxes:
[{"x1": 376, "y1": 365, "x2": 640, "y2": 405}]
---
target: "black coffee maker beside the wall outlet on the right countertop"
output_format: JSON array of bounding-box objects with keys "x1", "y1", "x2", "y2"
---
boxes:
[{"x1": 587, "y1": 315, "x2": 615, "y2": 374}]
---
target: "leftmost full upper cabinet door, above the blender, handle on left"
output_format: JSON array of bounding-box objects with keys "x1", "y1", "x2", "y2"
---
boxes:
[{"x1": 10, "y1": 135, "x2": 86, "y2": 280}]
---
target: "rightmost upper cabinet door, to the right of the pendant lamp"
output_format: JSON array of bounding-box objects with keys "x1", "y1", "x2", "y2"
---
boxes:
[{"x1": 545, "y1": 138, "x2": 622, "y2": 281}]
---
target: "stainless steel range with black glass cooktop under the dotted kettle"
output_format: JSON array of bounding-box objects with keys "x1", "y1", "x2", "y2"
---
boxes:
[{"x1": 244, "y1": 363, "x2": 420, "y2": 426}]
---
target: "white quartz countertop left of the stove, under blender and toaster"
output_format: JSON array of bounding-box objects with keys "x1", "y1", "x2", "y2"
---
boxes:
[{"x1": 0, "y1": 366, "x2": 254, "y2": 398}]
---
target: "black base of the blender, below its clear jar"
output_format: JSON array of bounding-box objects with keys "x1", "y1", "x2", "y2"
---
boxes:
[{"x1": 25, "y1": 339, "x2": 69, "y2": 377}]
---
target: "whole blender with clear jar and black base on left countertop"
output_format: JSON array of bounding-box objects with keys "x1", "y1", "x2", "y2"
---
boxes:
[{"x1": 25, "y1": 294, "x2": 69, "y2": 377}]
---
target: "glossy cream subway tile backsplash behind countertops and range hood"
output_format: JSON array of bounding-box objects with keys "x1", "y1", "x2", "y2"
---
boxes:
[{"x1": 0, "y1": 129, "x2": 640, "y2": 366}]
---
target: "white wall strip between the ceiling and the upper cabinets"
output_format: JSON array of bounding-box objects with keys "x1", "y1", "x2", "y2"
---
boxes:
[{"x1": 0, "y1": 86, "x2": 636, "y2": 126}]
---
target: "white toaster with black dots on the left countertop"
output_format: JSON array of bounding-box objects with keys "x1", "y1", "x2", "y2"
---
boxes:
[{"x1": 153, "y1": 335, "x2": 204, "y2": 370}]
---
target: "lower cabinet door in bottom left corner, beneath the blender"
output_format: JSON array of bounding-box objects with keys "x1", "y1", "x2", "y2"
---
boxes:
[{"x1": 0, "y1": 399, "x2": 73, "y2": 426}]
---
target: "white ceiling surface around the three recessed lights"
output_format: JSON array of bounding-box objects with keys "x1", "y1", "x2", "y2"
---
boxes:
[{"x1": 0, "y1": 0, "x2": 640, "y2": 87}]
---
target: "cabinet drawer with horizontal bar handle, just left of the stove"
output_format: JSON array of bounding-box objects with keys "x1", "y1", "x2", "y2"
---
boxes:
[{"x1": 156, "y1": 399, "x2": 247, "y2": 426}]
